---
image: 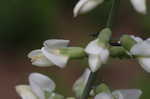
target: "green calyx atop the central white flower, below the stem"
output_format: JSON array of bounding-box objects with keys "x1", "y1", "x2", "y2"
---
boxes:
[{"x1": 98, "y1": 28, "x2": 112, "y2": 45}]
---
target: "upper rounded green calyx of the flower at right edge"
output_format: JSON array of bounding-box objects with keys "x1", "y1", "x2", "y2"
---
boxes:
[{"x1": 120, "y1": 35, "x2": 136, "y2": 51}]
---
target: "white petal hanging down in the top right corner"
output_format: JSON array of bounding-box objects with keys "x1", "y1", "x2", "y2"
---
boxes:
[{"x1": 131, "y1": 0, "x2": 147, "y2": 14}]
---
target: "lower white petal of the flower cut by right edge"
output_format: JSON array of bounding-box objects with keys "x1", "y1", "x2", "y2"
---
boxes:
[{"x1": 138, "y1": 57, "x2": 150, "y2": 73}]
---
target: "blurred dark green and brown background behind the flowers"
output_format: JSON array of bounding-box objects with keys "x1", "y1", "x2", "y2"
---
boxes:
[{"x1": 0, "y1": 0, "x2": 150, "y2": 99}]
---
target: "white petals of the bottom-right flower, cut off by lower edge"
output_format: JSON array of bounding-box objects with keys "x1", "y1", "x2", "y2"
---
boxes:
[{"x1": 94, "y1": 89, "x2": 142, "y2": 99}]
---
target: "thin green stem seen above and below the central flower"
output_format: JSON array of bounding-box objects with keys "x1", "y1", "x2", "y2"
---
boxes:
[{"x1": 81, "y1": 0, "x2": 120, "y2": 99}]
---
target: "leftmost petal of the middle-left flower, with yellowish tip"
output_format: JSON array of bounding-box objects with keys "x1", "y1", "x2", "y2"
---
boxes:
[{"x1": 28, "y1": 50, "x2": 53, "y2": 67}]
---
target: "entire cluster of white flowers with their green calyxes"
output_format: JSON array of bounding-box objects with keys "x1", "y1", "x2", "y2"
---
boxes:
[{"x1": 15, "y1": 0, "x2": 150, "y2": 99}]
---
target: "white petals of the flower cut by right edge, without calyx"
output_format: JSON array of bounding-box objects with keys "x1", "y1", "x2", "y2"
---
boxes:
[{"x1": 130, "y1": 39, "x2": 150, "y2": 72}]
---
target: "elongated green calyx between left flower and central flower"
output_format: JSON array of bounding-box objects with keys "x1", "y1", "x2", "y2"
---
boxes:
[{"x1": 60, "y1": 47, "x2": 86, "y2": 59}]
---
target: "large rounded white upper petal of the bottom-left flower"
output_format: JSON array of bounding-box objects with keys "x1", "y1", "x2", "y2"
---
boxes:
[{"x1": 29, "y1": 73, "x2": 56, "y2": 99}]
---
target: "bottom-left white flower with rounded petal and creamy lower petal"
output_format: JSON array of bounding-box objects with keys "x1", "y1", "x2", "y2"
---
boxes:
[{"x1": 16, "y1": 73, "x2": 56, "y2": 99}]
